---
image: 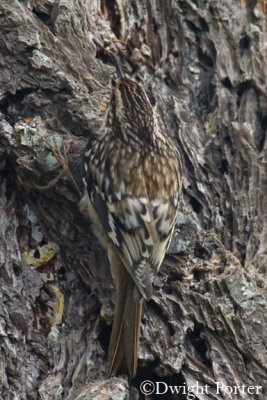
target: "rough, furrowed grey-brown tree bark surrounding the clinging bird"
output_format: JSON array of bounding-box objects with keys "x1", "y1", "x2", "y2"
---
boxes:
[{"x1": 0, "y1": 0, "x2": 267, "y2": 400}]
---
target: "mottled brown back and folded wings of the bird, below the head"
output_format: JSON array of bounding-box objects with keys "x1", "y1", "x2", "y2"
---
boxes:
[{"x1": 85, "y1": 134, "x2": 180, "y2": 298}]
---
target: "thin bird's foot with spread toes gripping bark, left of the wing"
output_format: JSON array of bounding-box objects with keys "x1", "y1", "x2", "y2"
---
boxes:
[{"x1": 34, "y1": 138, "x2": 82, "y2": 196}]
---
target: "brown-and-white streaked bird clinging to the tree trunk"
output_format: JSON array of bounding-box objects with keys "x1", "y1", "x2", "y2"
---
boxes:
[{"x1": 81, "y1": 55, "x2": 182, "y2": 379}]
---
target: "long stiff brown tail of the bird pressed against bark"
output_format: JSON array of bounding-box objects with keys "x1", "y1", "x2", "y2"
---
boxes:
[{"x1": 108, "y1": 253, "x2": 143, "y2": 378}]
